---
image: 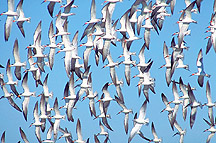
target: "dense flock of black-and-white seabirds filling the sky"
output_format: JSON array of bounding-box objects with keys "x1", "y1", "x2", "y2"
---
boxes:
[{"x1": 0, "y1": 0, "x2": 216, "y2": 143}]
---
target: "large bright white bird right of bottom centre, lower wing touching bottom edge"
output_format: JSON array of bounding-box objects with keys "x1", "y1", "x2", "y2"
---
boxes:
[{"x1": 128, "y1": 100, "x2": 149, "y2": 143}]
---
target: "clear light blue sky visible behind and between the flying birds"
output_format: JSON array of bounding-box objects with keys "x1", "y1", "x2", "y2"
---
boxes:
[{"x1": 0, "y1": 0, "x2": 216, "y2": 143}]
